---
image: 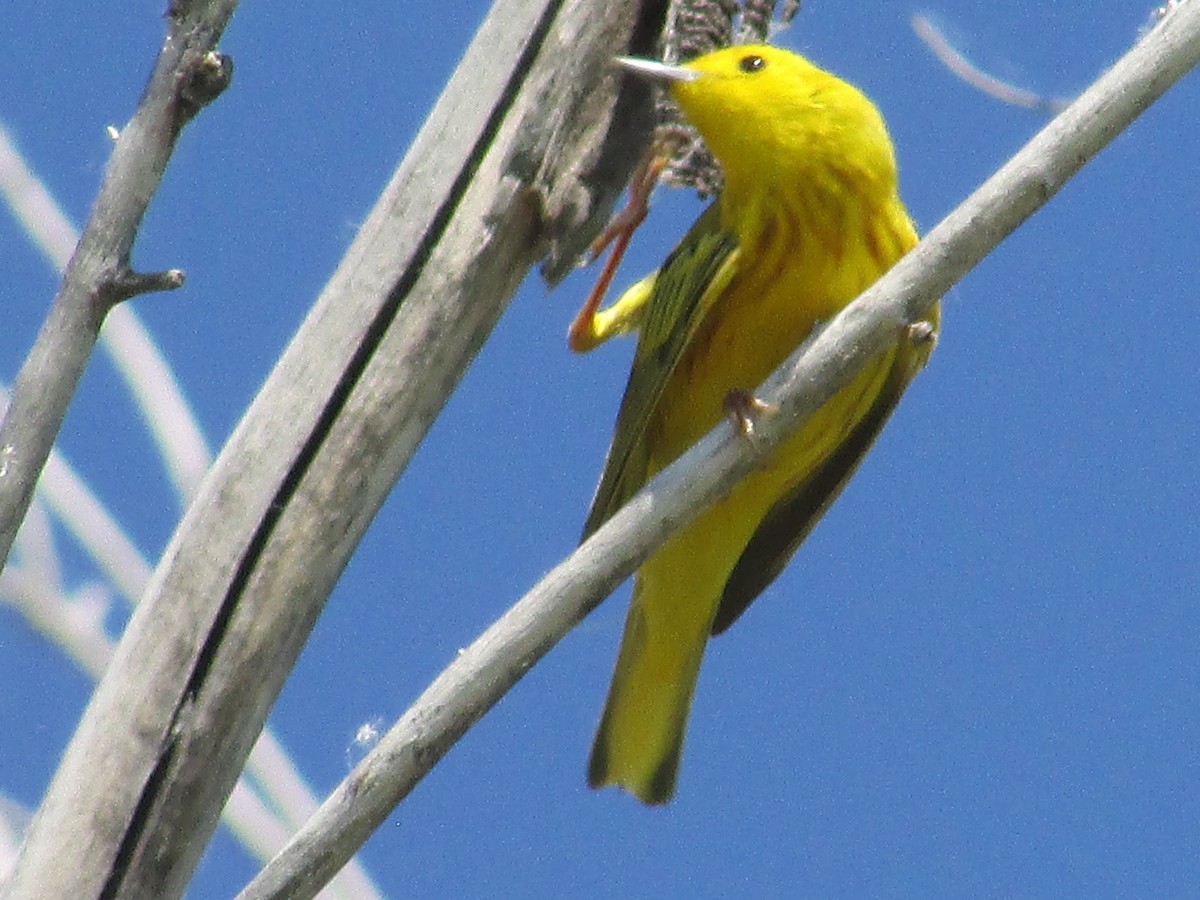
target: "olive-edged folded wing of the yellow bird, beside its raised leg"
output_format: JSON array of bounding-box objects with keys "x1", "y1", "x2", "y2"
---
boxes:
[{"x1": 583, "y1": 203, "x2": 738, "y2": 539}]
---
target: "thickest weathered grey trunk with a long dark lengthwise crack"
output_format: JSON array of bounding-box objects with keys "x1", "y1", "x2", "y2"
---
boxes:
[{"x1": 2, "y1": 0, "x2": 664, "y2": 898}]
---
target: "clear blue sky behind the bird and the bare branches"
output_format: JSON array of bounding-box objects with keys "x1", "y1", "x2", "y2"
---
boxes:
[{"x1": 0, "y1": 0, "x2": 1200, "y2": 898}]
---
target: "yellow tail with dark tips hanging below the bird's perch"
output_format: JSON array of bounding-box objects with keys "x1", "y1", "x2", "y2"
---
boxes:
[{"x1": 588, "y1": 580, "x2": 712, "y2": 804}]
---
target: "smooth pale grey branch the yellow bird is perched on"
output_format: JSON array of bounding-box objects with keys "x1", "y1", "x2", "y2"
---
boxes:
[{"x1": 239, "y1": 2, "x2": 1200, "y2": 900}]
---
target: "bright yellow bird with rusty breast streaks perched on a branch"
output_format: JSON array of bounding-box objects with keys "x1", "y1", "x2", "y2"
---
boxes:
[{"x1": 572, "y1": 46, "x2": 938, "y2": 804}]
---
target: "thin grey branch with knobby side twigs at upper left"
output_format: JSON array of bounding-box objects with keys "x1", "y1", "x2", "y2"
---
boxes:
[{"x1": 0, "y1": 0, "x2": 238, "y2": 566}]
